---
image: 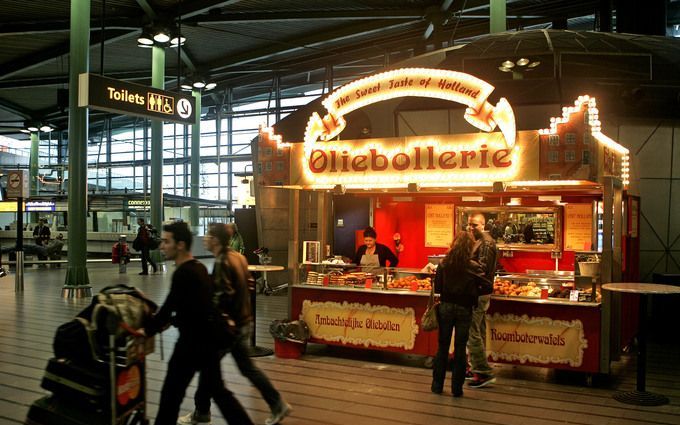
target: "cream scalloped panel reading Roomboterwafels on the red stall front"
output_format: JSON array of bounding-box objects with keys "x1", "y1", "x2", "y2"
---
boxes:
[{"x1": 486, "y1": 313, "x2": 588, "y2": 367}]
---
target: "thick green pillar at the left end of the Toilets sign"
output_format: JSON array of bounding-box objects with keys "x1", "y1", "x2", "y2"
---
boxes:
[{"x1": 61, "y1": 0, "x2": 92, "y2": 298}]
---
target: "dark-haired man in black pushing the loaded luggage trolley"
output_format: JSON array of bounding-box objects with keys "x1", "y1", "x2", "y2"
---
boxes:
[{"x1": 147, "y1": 222, "x2": 253, "y2": 425}]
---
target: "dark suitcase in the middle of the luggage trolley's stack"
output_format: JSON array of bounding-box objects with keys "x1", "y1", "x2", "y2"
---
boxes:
[{"x1": 41, "y1": 358, "x2": 111, "y2": 410}]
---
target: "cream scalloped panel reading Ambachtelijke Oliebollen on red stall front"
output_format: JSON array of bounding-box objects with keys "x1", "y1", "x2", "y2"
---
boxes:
[{"x1": 300, "y1": 300, "x2": 418, "y2": 350}]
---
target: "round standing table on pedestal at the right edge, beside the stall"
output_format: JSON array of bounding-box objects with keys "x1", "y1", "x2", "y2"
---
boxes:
[{"x1": 602, "y1": 282, "x2": 680, "y2": 406}]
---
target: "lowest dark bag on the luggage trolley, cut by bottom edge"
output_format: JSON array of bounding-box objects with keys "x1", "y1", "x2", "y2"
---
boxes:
[{"x1": 24, "y1": 396, "x2": 111, "y2": 425}]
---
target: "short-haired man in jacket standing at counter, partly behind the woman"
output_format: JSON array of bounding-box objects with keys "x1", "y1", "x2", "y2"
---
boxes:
[{"x1": 466, "y1": 213, "x2": 497, "y2": 388}]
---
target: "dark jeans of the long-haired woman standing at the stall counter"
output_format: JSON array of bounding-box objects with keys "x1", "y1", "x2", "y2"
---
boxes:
[{"x1": 432, "y1": 302, "x2": 472, "y2": 393}]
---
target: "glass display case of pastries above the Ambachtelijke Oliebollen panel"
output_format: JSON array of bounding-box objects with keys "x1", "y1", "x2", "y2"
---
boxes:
[{"x1": 299, "y1": 262, "x2": 434, "y2": 292}]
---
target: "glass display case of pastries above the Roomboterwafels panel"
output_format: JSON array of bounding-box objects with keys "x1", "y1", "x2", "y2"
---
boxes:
[{"x1": 493, "y1": 270, "x2": 602, "y2": 303}]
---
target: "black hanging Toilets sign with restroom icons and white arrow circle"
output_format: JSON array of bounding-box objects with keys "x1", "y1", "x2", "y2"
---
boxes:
[{"x1": 78, "y1": 74, "x2": 196, "y2": 124}]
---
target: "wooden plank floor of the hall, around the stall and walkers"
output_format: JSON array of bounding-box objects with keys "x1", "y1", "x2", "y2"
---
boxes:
[{"x1": 0, "y1": 265, "x2": 680, "y2": 425}]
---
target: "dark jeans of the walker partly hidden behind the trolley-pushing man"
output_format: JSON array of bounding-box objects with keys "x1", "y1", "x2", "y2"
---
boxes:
[{"x1": 194, "y1": 324, "x2": 281, "y2": 413}]
